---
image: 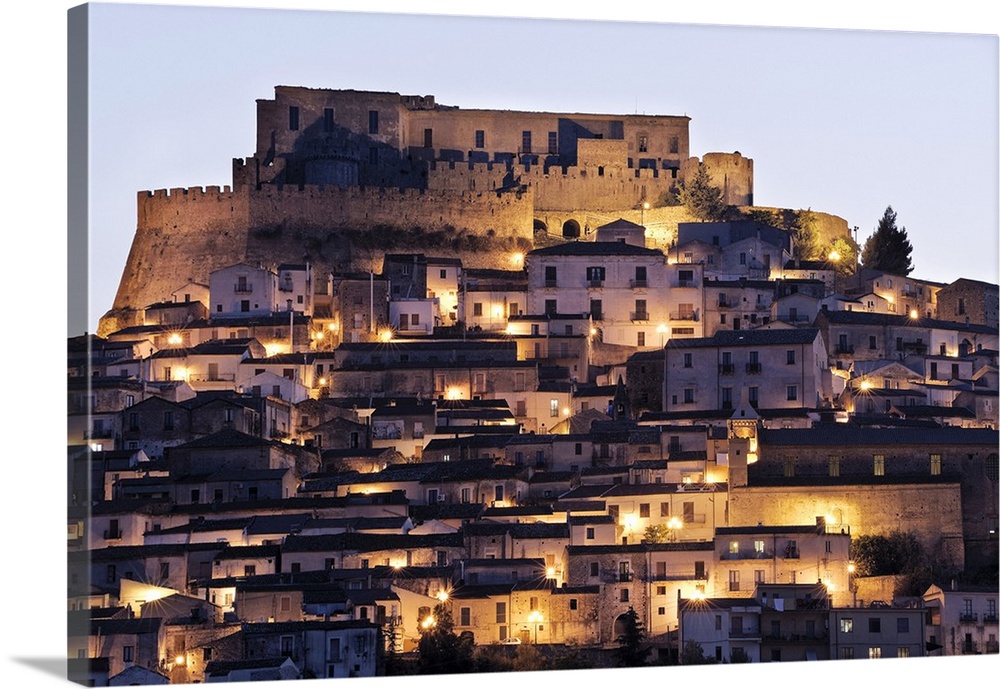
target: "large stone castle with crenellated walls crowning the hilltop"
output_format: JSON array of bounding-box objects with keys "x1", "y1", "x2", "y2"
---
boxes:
[{"x1": 105, "y1": 86, "x2": 753, "y2": 333}]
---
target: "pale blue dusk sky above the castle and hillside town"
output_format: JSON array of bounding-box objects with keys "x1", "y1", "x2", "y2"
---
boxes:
[{"x1": 80, "y1": 4, "x2": 998, "y2": 334}]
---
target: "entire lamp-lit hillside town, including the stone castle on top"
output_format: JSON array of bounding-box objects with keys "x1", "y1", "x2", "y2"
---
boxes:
[{"x1": 67, "y1": 87, "x2": 1000, "y2": 686}]
